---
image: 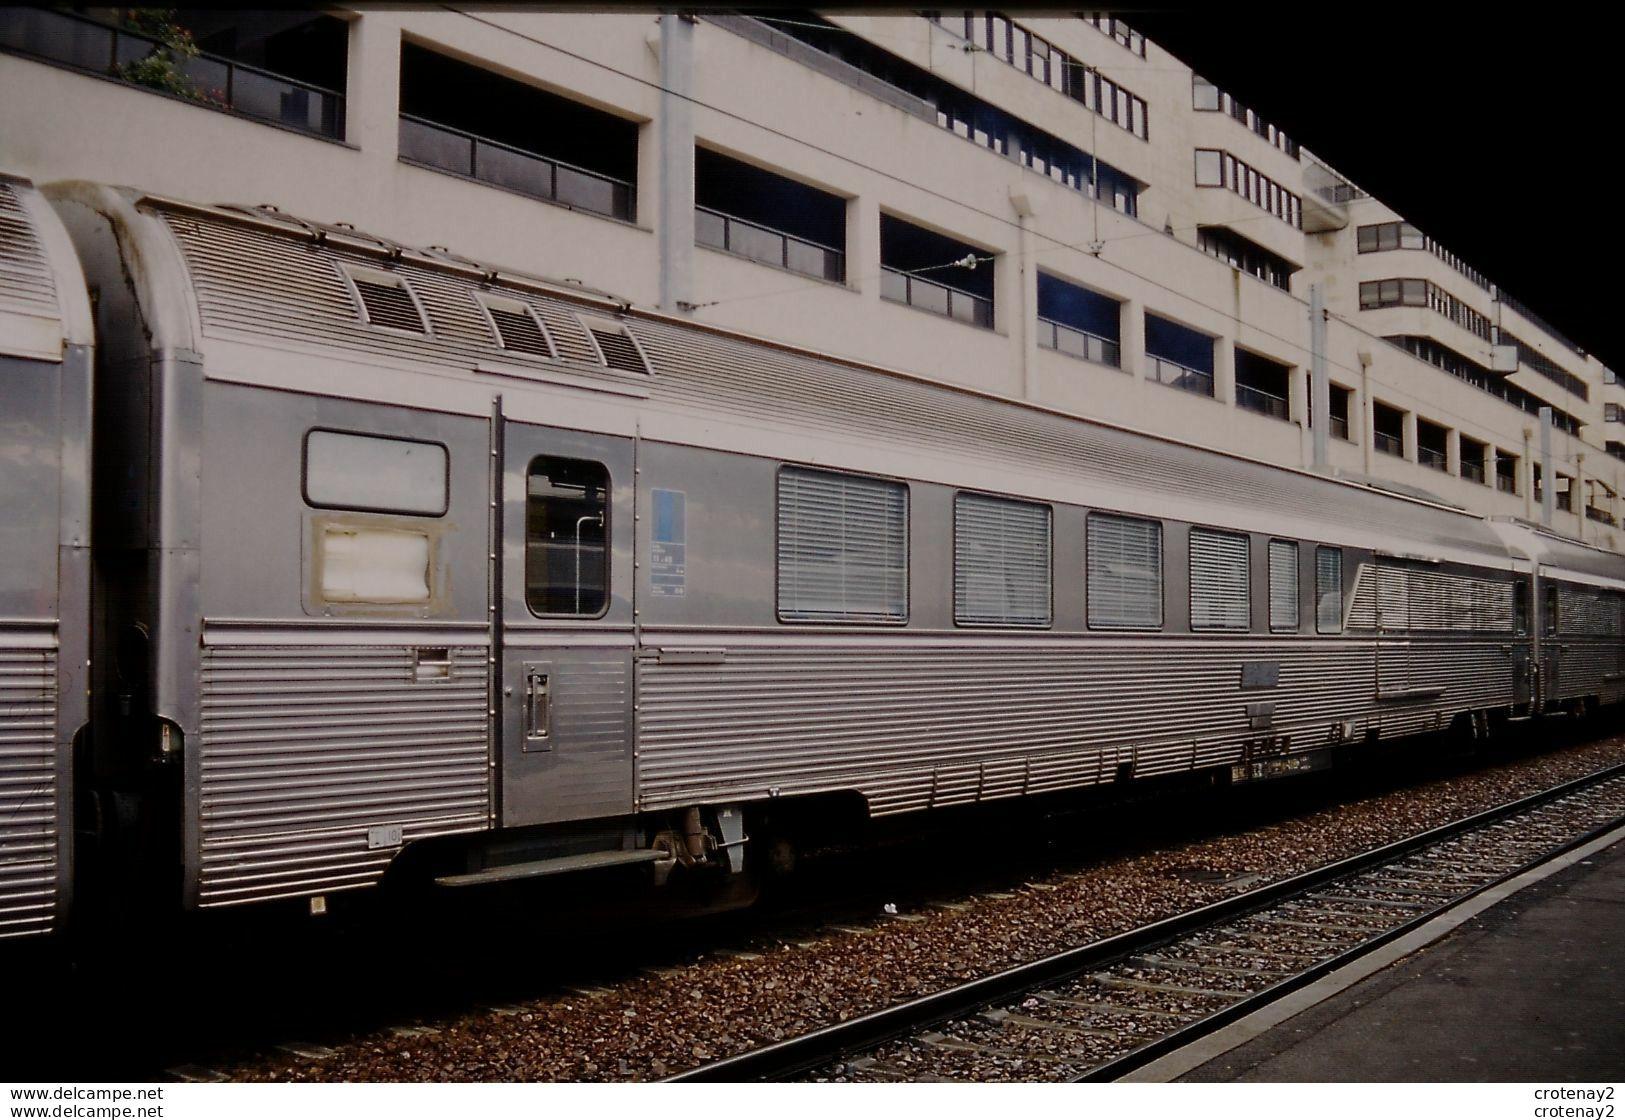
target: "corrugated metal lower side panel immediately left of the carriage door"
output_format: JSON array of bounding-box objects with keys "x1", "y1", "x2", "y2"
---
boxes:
[{"x1": 198, "y1": 645, "x2": 491, "y2": 905}]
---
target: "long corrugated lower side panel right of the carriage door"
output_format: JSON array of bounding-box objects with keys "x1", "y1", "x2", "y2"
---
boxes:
[{"x1": 637, "y1": 632, "x2": 1511, "y2": 813}]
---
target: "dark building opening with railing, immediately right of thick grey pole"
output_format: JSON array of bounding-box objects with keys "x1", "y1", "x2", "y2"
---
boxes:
[{"x1": 694, "y1": 148, "x2": 847, "y2": 283}]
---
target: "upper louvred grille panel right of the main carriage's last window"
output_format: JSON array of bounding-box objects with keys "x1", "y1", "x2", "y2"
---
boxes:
[{"x1": 1349, "y1": 564, "x2": 1513, "y2": 634}]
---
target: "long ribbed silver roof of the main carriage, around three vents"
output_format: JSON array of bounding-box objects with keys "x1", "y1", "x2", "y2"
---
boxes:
[{"x1": 98, "y1": 192, "x2": 1511, "y2": 567}]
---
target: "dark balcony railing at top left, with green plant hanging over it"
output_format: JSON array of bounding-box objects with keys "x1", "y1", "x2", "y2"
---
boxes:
[{"x1": 0, "y1": 8, "x2": 345, "y2": 140}]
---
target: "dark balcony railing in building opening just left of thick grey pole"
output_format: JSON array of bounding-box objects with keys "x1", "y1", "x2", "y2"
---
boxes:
[{"x1": 400, "y1": 114, "x2": 635, "y2": 221}]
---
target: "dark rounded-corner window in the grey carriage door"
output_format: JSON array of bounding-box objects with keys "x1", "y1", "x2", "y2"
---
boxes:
[{"x1": 525, "y1": 455, "x2": 609, "y2": 618}]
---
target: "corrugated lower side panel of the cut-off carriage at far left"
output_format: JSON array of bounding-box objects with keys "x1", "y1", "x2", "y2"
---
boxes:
[{"x1": 0, "y1": 637, "x2": 60, "y2": 938}]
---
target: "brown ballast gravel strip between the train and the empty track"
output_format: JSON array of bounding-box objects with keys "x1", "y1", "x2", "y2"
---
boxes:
[{"x1": 232, "y1": 738, "x2": 1625, "y2": 1083}]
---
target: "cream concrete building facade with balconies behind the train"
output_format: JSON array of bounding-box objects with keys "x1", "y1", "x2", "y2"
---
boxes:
[{"x1": 0, "y1": 7, "x2": 1625, "y2": 549}]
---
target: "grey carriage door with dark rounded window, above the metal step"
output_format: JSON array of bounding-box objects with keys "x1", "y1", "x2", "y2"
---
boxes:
[{"x1": 499, "y1": 421, "x2": 634, "y2": 827}]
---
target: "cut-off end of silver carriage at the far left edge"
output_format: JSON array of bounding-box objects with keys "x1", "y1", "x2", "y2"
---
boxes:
[{"x1": 0, "y1": 176, "x2": 91, "y2": 938}]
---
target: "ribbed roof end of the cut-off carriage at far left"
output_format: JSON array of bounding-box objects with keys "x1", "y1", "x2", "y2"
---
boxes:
[{"x1": 0, "y1": 171, "x2": 93, "y2": 361}]
